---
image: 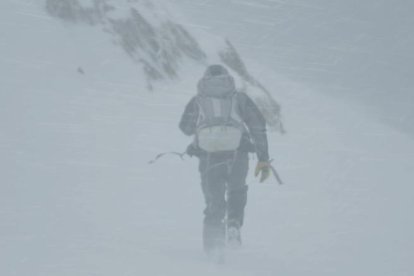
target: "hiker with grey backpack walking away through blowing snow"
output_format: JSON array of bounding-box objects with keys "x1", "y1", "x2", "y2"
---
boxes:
[{"x1": 179, "y1": 64, "x2": 270, "y2": 254}]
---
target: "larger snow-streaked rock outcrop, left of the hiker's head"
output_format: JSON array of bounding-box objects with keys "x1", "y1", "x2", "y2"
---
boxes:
[{"x1": 46, "y1": 0, "x2": 206, "y2": 89}]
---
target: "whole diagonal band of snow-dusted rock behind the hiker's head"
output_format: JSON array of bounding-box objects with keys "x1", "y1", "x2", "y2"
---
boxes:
[{"x1": 45, "y1": 0, "x2": 284, "y2": 132}]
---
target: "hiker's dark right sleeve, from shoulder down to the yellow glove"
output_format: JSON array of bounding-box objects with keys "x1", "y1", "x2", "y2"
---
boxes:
[{"x1": 239, "y1": 93, "x2": 269, "y2": 162}]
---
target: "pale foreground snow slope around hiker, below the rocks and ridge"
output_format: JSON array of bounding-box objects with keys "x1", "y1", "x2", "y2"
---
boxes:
[{"x1": 0, "y1": 1, "x2": 414, "y2": 276}]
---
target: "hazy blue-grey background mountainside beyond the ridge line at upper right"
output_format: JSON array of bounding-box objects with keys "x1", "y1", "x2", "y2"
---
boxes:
[{"x1": 172, "y1": 0, "x2": 414, "y2": 137}]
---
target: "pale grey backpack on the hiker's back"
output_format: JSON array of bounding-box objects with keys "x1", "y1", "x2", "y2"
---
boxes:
[{"x1": 195, "y1": 93, "x2": 246, "y2": 152}]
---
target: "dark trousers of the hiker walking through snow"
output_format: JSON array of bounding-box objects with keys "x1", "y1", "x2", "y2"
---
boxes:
[{"x1": 199, "y1": 151, "x2": 249, "y2": 250}]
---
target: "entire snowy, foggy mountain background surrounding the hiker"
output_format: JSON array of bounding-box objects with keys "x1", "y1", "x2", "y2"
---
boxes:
[{"x1": 0, "y1": 0, "x2": 414, "y2": 276}]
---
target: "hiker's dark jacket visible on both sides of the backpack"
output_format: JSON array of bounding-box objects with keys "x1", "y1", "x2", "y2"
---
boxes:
[{"x1": 179, "y1": 92, "x2": 269, "y2": 161}]
